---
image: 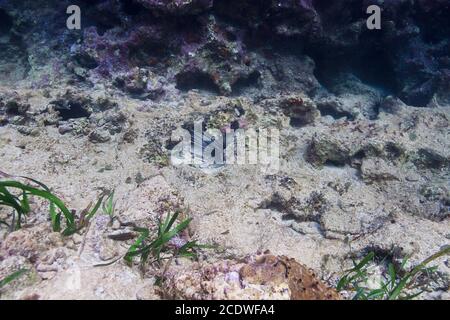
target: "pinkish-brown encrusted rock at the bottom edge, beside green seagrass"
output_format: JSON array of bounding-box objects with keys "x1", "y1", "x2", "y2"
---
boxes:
[{"x1": 161, "y1": 253, "x2": 341, "y2": 300}]
